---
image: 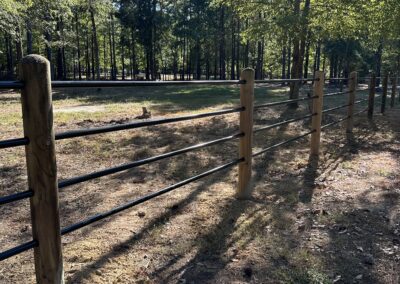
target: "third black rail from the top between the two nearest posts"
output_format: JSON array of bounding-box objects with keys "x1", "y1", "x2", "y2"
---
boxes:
[{"x1": 58, "y1": 133, "x2": 244, "y2": 189}]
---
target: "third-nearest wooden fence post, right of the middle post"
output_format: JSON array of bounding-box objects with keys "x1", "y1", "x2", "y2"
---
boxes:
[{"x1": 311, "y1": 71, "x2": 325, "y2": 156}]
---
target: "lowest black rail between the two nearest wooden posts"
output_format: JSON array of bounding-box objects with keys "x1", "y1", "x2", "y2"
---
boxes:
[{"x1": 61, "y1": 158, "x2": 244, "y2": 235}]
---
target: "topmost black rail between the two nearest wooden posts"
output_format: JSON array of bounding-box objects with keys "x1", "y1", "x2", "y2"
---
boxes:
[{"x1": 51, "y1": 80, "x2": 246, "y2": 89}]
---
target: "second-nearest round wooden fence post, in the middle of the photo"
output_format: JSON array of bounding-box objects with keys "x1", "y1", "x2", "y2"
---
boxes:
[{"x1": 237, "y1": 68, "x2": 254, "y2": 199}]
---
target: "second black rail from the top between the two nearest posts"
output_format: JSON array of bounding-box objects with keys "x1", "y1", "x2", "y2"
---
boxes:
[{"x1": 55, "y1": 107, "x2": 244, "y2": 140}]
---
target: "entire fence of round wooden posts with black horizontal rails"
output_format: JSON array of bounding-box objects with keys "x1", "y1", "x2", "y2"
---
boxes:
[{"x1": 0, "y1": 55, "x2": 397, "y2": 283}]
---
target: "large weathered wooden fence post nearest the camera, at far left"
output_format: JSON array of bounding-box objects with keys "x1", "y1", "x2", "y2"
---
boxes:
[{"x1": 20, "y1": 55, "x2": 64, "y2": 283}]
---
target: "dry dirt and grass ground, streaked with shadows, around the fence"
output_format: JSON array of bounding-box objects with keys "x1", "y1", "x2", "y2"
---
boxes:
[{"x1": 0, "y1": 85, "x2": 400, "y2": 284}]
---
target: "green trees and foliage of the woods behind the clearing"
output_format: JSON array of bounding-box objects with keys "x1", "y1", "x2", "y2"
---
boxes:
[{"x1": 0, "y1": 0, "x2": 400, "y2": 79}]
